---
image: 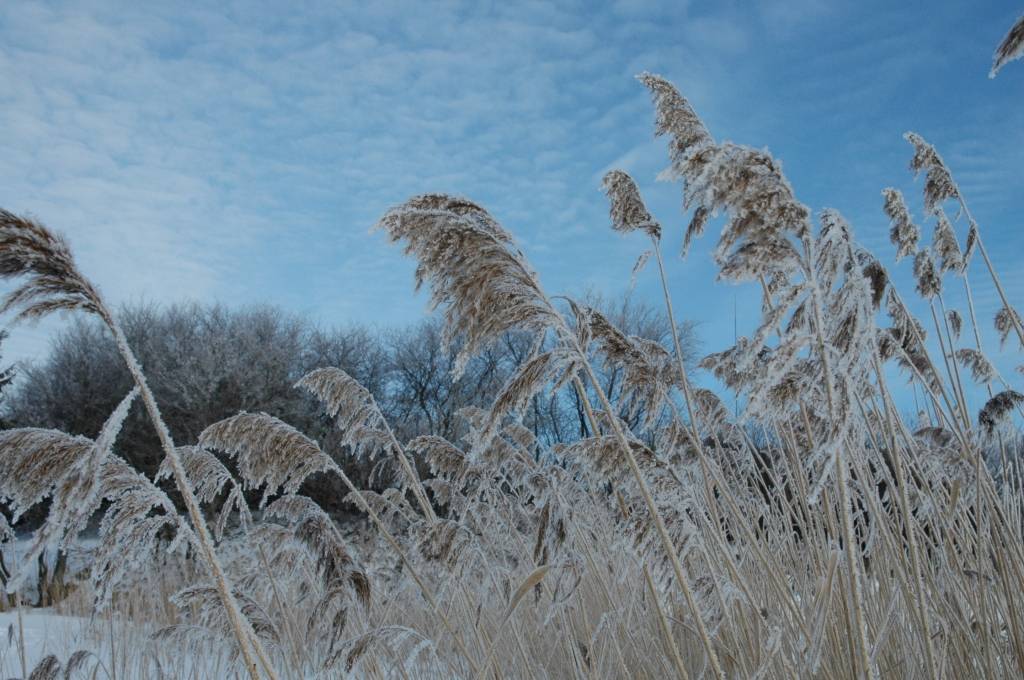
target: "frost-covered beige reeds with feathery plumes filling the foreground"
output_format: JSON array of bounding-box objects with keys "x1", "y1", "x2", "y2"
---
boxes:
[{"x1": 0, "y1": 19, "x2": 1024, "y2": 680}]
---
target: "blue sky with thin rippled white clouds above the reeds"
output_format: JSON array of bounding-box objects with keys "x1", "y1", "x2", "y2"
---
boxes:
[{"x1": 0, "y1": 0, "x2": 1024, "y2": 413}]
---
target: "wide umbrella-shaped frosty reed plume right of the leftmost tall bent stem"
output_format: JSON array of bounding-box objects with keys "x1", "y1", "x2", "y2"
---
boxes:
[{"x1": 199, "y1": 412, "x2": 336, "y2": 508}]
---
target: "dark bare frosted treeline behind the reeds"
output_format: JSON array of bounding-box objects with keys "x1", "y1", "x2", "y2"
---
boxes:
[{"x1": 2, "y1": 296, "x2": 694, "y2": 520}]
